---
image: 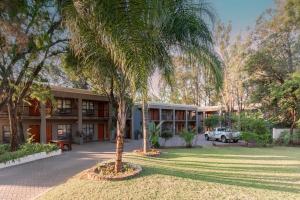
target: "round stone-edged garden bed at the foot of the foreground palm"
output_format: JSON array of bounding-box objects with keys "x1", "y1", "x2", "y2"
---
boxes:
[{"x1": 78, "y1": 161, "x2": 142, "y2": 181}]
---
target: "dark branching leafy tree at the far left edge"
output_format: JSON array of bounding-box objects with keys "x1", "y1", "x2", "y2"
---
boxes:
[{"x1": 0, "y1": 0, "x2": 67, "y2": 151}]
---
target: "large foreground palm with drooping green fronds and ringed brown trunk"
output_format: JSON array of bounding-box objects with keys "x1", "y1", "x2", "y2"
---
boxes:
[{"x1": 65, "y1": 0, "x2": 223, "y2": 172}]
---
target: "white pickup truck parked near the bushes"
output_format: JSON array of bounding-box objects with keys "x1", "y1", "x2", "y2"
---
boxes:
[{"x1": 205, "y1": 127, "x2": 240, "y2": 143}]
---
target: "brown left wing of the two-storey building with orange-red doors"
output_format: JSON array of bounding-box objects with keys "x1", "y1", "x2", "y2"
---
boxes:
[{"x1": 0, "y1": 87, "x2": 131, "y2": 143}]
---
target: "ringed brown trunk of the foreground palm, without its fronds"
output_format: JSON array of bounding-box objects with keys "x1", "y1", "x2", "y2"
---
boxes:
[{"x1": 115, "y1": 96, "x2": 126, "y2": 173}]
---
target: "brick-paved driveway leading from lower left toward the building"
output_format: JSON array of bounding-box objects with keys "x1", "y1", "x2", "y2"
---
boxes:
[{"x1": 0, "y1": 140, "x2": 142, "y2": 200}]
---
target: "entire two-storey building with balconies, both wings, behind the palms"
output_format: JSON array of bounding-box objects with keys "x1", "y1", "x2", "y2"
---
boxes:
[{"x1": 0, "y1": 86, "x2": 234, "y2": 144}]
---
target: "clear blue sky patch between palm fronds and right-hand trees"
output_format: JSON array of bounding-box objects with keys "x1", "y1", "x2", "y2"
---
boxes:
[{"x1": 207, "y1": 0, "x2": 275, "y2": 35}]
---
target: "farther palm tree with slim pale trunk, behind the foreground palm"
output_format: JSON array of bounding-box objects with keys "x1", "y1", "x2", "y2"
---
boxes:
[{"x1": 142, "y1": 0, "x2": 222, "y2": 153}]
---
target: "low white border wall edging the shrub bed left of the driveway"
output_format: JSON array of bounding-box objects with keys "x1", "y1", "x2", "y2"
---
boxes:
[{"x1": 0, "y1": 149, "x2": 62, "y2": 169}]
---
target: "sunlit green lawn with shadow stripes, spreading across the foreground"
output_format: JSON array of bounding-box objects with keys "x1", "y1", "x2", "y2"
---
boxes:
[{"x1": 40, "y1": 147, "x2": 300, "y2": 200}]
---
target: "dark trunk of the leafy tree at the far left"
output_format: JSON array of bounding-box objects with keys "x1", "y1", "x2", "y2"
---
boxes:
[{"x1": 7, "y1": 99, "x2": 19, "y2": 151}]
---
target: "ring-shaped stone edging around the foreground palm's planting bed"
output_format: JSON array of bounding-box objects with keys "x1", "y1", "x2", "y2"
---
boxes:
[{"x1": 77, "y1": 160, "x2": 142, "y2": 181}]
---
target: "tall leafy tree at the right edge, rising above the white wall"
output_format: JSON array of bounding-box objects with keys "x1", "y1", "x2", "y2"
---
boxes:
[{"x1": 246, "y1": 0, "x2": 300, "y2": 130}]
